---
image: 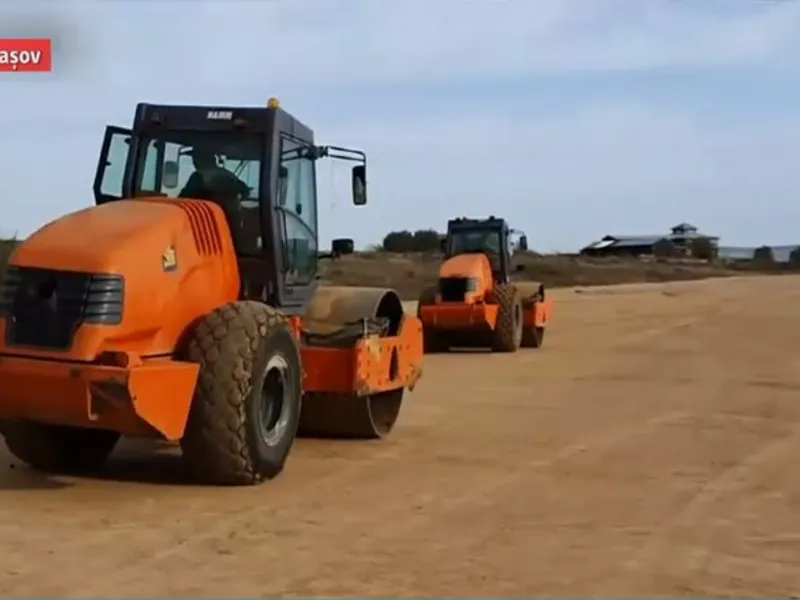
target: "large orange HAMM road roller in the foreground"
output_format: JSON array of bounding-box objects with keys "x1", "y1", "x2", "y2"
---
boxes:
[{"x1": 0, "y1": 99, "x2": 423, "y2": 485}]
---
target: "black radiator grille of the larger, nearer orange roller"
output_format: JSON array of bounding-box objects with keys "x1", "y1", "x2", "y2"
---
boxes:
[{"x1": 0, "y1": 266, "x2": 125, "y2": 350}]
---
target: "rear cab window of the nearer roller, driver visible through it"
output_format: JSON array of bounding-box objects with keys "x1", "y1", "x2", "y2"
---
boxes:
[{"x1": 134, "y1": 131, "x2": 261, "y2": 207}]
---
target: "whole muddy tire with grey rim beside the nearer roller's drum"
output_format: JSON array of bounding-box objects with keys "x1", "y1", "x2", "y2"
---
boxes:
[{"x1": 181, "y1": 302, "x2": 303, "y2": 485}]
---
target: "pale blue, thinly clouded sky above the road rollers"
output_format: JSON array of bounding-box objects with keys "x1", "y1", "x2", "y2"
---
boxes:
[{"x1": 0, "y1": 0, "x2": 800, "y2": 252}]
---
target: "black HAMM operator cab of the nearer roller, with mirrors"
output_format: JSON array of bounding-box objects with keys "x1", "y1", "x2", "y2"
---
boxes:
[{"x1": 93, "y1": 99, "x2": 367, "y2": 314}]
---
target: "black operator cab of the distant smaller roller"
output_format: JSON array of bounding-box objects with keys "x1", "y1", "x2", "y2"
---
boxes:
[{"x1": 443, "y1": 217, "x2": 528, "y2": 283}]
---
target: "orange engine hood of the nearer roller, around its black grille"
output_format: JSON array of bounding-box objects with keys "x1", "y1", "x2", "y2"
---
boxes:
[{"x1": 0, "y1": 198, "x2": 240, "y2": 361}]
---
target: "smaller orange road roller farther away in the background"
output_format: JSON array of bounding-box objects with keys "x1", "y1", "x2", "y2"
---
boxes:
[{"x1": 417, "y1": 217, "x2": 551, "y2": 353}]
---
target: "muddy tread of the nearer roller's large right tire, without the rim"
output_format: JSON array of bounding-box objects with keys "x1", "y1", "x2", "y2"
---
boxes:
[{"x1": 181, "y1": 301, "x2": 289, "y2": 485}]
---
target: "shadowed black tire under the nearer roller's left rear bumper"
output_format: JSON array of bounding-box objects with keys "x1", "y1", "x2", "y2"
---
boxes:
[{"x1": 0, "y1": 421, "x2": 120, "y2": 473}]
